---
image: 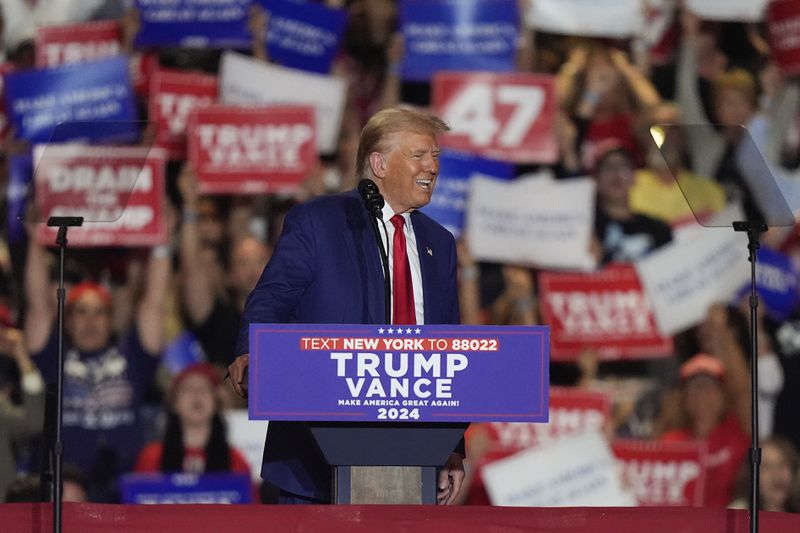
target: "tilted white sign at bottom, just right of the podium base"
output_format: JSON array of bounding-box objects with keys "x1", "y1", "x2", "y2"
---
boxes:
[{"x1": 483, "y1": 431, "x2": 635, "y2": 507}]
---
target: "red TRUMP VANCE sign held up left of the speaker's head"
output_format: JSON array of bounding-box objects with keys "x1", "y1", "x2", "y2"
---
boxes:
[{"x1": 188, "y1": 104, "x2": 317, "y2": 194}]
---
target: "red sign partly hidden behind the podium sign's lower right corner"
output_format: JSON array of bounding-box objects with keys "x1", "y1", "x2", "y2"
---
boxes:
[{"x1": 476, "y1": 387, "x2": 611, "y2": 454}]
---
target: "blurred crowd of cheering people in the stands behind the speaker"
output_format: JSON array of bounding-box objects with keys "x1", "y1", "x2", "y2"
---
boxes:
[{"x1": 0, "y1": 0, "x2": 800, "y2": 512}]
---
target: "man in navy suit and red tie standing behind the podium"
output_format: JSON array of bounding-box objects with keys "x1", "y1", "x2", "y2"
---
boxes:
[{"x1": 229, "y1": 109, "x2": 464, "y2": 504}]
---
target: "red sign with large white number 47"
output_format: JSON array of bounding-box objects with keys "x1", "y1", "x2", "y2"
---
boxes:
[{"x1": 432, "y1": 72, "x2": 558, "y2": 163}]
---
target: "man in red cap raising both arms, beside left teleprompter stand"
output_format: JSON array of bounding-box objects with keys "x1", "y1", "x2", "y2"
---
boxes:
[{"x1": 25, "y1": 238, "x2": 170, "y2": 502}]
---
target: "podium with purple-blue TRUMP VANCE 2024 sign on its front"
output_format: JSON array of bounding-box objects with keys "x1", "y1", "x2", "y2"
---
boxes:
[{"x1": 249, "y1": 324, "x2": 549, "y2": 504}]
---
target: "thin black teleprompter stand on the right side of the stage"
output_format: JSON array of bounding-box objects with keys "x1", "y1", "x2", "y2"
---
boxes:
[{"x1": 733, "y1": 220, "x2": 767, "y2": 533}]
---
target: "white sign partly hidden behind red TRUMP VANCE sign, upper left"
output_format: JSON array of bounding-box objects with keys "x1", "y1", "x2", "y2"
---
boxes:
[{"x1": 219, "y1": 52, "x2": 347, "y2": 153}]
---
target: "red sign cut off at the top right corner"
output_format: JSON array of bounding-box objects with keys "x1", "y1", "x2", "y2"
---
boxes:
[{"x1": 767, "y1": 0, "x2": 800, "y2": 76}]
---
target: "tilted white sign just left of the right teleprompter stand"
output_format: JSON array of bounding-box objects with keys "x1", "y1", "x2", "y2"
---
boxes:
[{"x1": 635, "y1": 228, "x2": 750, "y2": 335}]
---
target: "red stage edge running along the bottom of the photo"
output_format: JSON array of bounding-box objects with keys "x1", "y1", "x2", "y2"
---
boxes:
[{"x1": 0, "y1": 503, "x2": 800, "y2": 533}]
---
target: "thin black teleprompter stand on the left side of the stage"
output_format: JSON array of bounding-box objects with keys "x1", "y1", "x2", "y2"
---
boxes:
[{"x1": 47, "y1": 217, "x2": 83, "y2": 533}]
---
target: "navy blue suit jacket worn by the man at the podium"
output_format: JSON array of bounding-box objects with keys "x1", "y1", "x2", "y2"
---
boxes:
[{"x1": 237, "y1": 191, "x2": 459, "y2": 500}]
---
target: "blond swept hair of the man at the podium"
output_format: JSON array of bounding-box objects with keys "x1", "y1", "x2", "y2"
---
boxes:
[{"x1": 356, "y1": 107, "x2": 450, "y2": 179}]
